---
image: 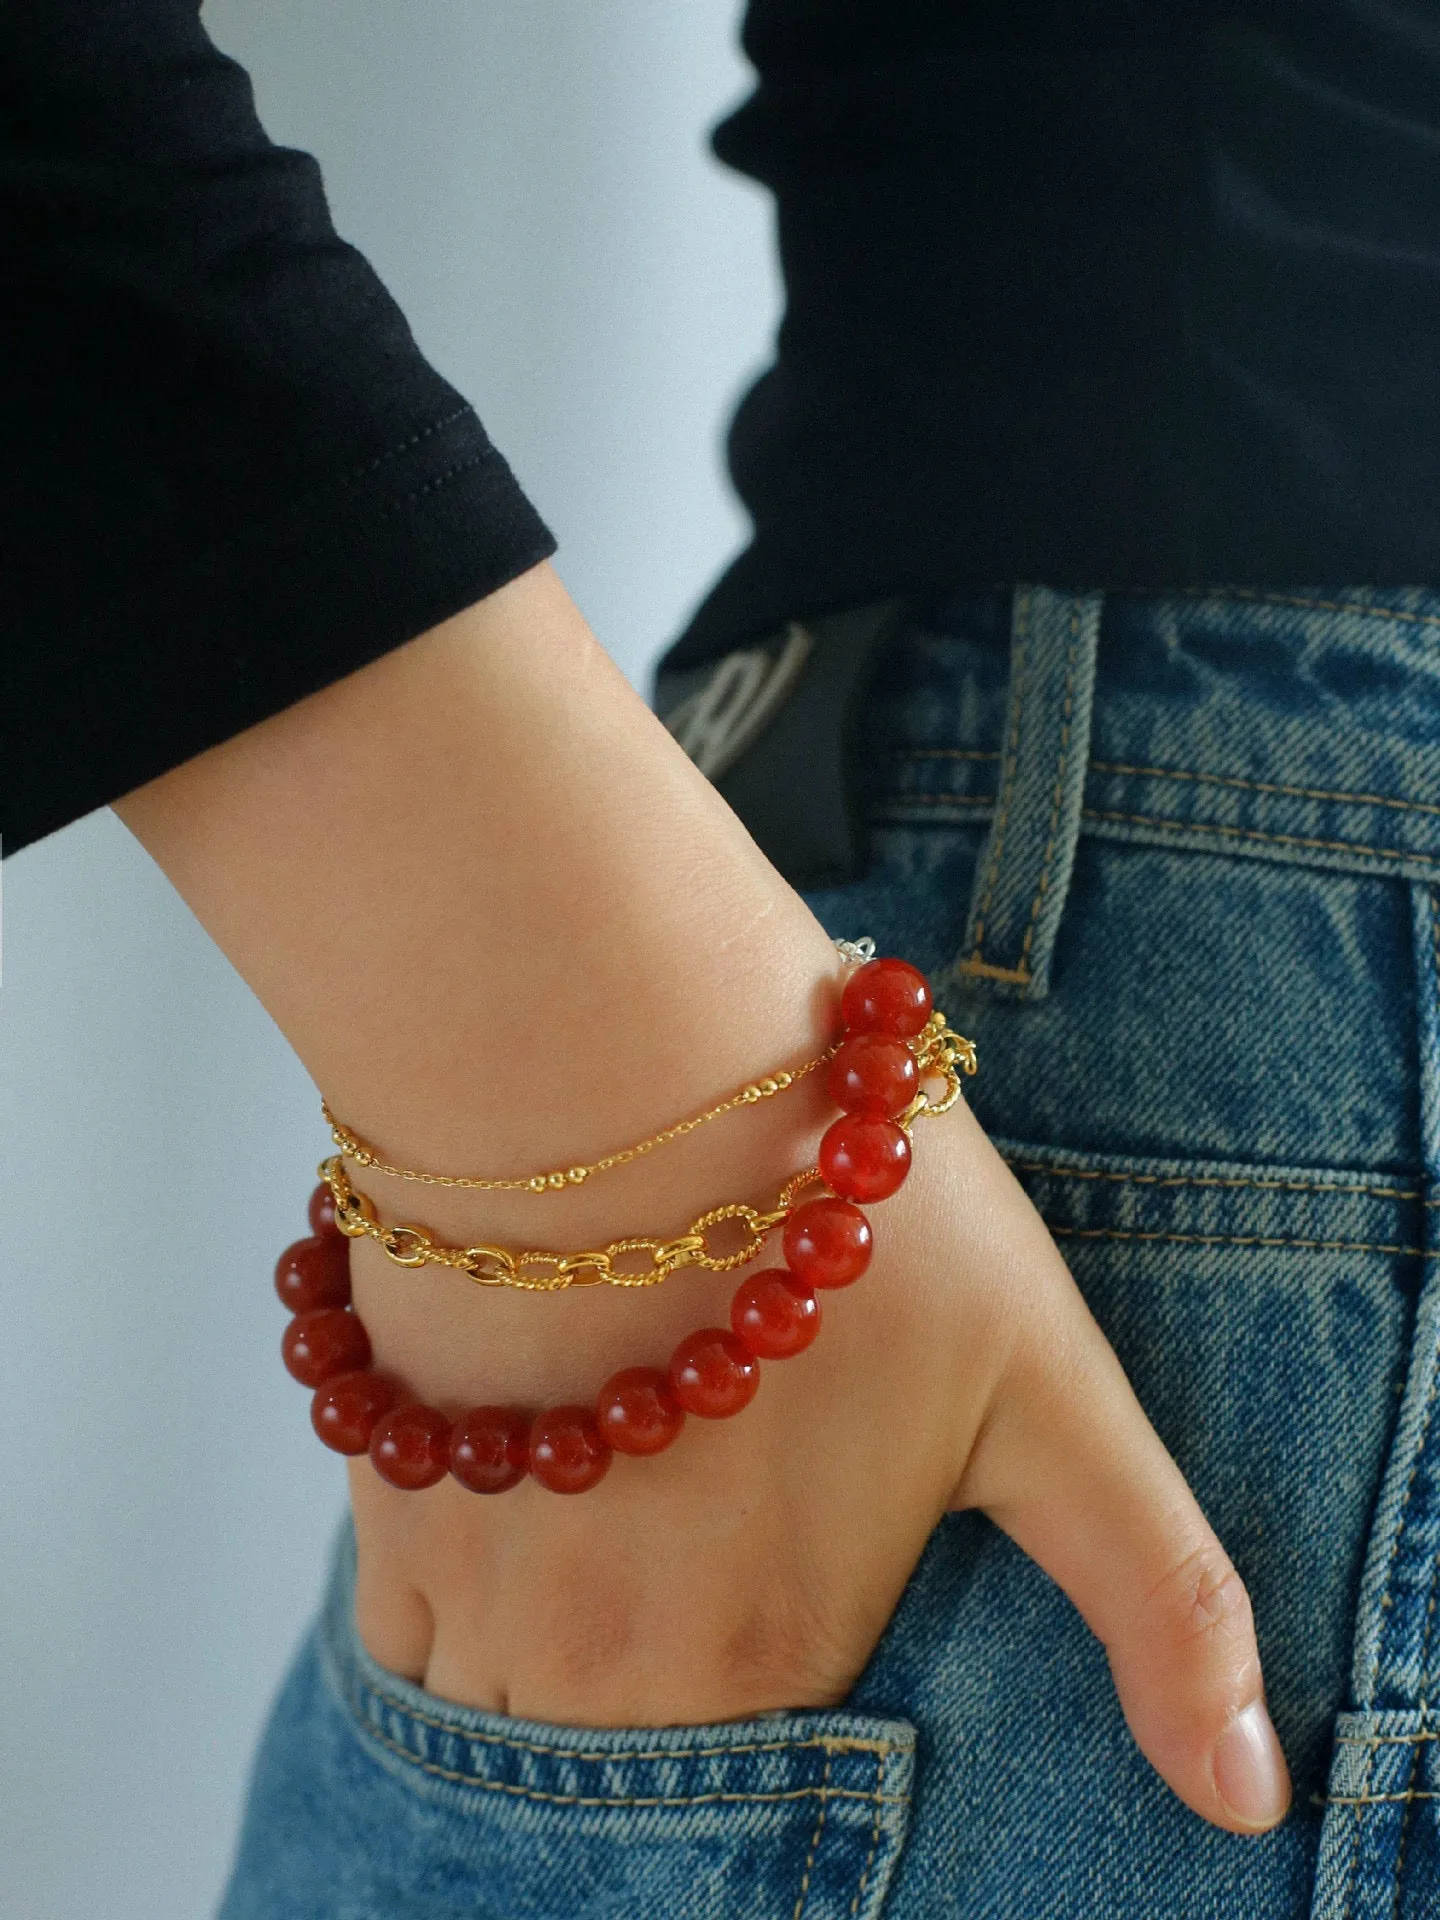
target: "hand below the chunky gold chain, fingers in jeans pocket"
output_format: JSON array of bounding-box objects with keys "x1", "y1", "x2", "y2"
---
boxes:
[{"x1": 351, "y1": 1096, "x2": 1288, "y2": 1832}]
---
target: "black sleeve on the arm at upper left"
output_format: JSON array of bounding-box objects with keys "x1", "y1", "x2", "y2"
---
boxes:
[{"x1": 0, "y1": 0, "x2": 555, "y2": 854}]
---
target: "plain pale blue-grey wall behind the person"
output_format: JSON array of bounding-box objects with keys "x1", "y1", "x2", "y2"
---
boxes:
[{"x1": 0, "y1": 0, "x2": 778, "y2": 1920}]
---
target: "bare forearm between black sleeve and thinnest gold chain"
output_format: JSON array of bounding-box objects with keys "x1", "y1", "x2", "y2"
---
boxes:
[{"x1": 115, "y1": 564, "x2": 829, "y2": 1173}]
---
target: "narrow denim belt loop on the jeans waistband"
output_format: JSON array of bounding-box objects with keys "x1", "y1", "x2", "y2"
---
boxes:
[{"x1": 950, "y1": 586, "x2": 1104, "y2": 1000}]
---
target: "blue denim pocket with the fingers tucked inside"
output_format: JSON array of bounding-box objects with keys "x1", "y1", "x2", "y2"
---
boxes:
[{"x1": 223, "y1": 1528, "x2": 916, "y2": 1920}]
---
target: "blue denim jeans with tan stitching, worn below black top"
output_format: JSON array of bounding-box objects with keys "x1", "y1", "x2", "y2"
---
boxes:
[{"x1": 223, "y1": 588, "x2": 1440, "y2": 1920}]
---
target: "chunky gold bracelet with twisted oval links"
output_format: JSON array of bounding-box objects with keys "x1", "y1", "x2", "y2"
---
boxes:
[{"x1": 317, "y1": 1010, "x2": 975, "y2": 1292}]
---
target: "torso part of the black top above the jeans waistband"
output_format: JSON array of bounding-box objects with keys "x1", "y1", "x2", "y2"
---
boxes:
[{"x1": 670, "y1": 0, "x2": 1440, "y2": 664}]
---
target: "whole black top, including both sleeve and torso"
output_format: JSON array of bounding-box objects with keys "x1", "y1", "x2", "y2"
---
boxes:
[{"x1": 0, "y1": 0, "x2": 1440, "y2": 852}]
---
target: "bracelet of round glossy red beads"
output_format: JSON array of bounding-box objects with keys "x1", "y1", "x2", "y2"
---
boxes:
[{"x1": 275, "y1": 960, "x2": 973, "y2": 1494}]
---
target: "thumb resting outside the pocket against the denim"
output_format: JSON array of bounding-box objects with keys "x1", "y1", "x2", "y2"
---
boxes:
[{"x1": 956, "y1": 1305, "x2": 1290, "y2": 1834}]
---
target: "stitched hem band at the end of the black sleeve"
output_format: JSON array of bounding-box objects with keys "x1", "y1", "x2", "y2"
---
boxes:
[{"x1": 0, "y1": 407, "x2": 555, "y2": 854}]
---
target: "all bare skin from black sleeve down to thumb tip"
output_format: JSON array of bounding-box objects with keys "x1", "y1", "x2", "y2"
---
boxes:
[{"x1": 115, "y1": 564, "x2": 1288, "y2": 1832}]
